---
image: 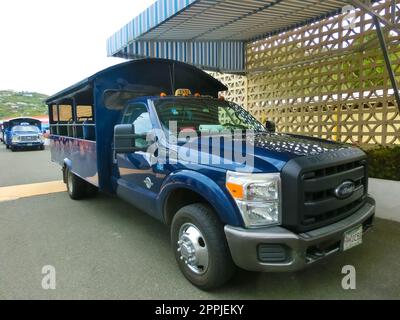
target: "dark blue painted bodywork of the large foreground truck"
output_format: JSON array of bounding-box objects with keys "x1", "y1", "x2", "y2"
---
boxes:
[{"x1": 47, "y1": 58, "x2": 354, "y2": 230}]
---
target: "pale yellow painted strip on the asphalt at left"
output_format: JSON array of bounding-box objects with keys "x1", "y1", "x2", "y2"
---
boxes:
[{"x1": 0, "y1": 181, "x2": 67, "y2": 202}]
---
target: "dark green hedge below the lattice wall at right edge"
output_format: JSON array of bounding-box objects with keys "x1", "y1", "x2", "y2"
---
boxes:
[{"x1": 364, "y1": 146, "x2": 400, "y2": 181}]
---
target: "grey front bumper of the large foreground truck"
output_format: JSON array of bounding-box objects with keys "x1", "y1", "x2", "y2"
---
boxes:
[{"x1": 225, "y1": 198, "x2": 375, "y2": 272}]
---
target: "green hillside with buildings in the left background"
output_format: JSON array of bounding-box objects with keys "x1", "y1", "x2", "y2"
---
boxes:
[{"x1": 0, "y1": 90, "x2": 47, "y2": 119}]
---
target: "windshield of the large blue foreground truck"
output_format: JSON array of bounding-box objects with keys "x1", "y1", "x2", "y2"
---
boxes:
[{"x1": 154, "y1": 98, "x2": 266, "y2": 133}]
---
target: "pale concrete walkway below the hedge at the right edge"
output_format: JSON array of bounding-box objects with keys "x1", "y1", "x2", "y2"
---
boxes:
[{"x1": 369, "y1": 178, "x2": 400, "y2": 222}]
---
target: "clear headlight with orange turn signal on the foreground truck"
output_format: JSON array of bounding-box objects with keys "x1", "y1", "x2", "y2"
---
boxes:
[{"x1": 226, "y1": 171, "x2": 281, "y2": 228}]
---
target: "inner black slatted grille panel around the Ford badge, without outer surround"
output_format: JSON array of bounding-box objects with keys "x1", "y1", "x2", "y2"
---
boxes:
[{"x1": 300, "y1": 160, "x2": 367, "y2": 228}]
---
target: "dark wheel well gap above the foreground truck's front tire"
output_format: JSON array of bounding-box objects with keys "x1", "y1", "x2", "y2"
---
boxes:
[{"x1": 164, "y1": 188, "x2": 211, "y2": 225}]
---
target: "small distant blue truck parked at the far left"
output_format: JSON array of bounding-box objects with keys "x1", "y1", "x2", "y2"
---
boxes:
[{"x1": 4, "y1": 117, "x2": 44, "y2": 151}]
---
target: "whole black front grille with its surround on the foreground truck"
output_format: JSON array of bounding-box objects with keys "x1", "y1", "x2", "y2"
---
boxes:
[{"x1": 281, "y1": 148, "x2": 368, "y2": 232}]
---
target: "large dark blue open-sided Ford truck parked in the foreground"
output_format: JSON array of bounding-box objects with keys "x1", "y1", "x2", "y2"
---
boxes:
[{"x1": 46, "y1": 59, "x2": 375, "y2": 290}]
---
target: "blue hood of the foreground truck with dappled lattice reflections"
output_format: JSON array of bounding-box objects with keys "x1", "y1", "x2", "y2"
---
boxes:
[{"x1": 173, "y1": 133, "x2": 352, "y2": 172}]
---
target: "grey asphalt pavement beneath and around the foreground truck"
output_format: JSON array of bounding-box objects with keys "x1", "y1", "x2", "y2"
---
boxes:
[{"x1": 0, "y1": 145, "x2": 400, "y2": 299}]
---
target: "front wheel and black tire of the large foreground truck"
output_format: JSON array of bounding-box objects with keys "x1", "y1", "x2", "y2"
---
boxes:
[{"x1": 171, "y1": 203, "x2": 236, "y2": 290}]
